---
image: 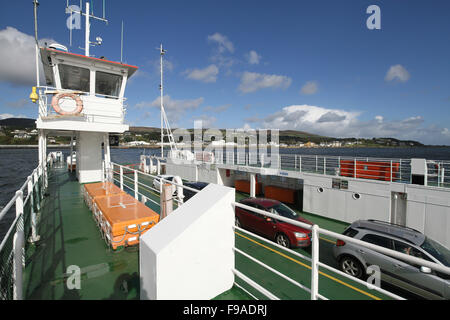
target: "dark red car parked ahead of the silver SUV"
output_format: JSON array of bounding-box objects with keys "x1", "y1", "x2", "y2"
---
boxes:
[{"x1": 235, "y1": 198, "x2": 313, "y2": 248}]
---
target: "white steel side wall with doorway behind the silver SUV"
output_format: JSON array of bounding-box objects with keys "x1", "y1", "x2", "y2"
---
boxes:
[{"x1": 303, "y1": 174, "x2": 450, "y2": 247}]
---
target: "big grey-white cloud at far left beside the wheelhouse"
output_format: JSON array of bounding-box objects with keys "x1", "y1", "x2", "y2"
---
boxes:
[{"x1": 0, "y1": 27, "x2": 55, "y2": 86}]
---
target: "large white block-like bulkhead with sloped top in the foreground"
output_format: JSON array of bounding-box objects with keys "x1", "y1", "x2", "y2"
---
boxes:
[{"x1": 139, "y1": 184, "x2": 235, "y2": 300}]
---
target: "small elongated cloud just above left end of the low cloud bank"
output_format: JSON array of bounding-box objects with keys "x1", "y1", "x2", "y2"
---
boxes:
[{"x1": 239, "y1": 71, "x2": 292, "y2": 93}]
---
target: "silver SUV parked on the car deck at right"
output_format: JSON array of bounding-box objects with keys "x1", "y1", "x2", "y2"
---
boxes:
[{"x1": 333, "y1": 220, "x2": 450, "y2": 299}]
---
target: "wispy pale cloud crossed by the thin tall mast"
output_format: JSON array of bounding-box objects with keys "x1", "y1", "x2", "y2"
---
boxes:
[{"x1": 135, "y1": 95, "x2": 204, "y2": 122}]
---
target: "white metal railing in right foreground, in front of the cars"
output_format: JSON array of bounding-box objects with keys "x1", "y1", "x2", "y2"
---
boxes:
[{"x1": 233, "y1": 202, "x2": 450, "y2": 300}]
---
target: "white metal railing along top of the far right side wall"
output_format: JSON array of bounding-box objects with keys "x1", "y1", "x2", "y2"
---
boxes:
[{"x1": 168, "y1": 150, "x2": 450, "y2": 187}]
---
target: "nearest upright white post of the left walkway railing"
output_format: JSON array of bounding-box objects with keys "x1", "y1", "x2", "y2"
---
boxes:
[{"x1": 13, "y1": 190, "x2": 25, "y2": 300}]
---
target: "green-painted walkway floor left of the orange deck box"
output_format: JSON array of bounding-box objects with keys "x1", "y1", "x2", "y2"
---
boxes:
[{"x1": 24, "y1": 168, "x2": 139, "y2": 299}]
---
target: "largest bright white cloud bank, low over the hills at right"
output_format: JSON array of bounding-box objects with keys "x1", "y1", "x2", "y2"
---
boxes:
[{"x1": 245, "y1": 105, "x2": 450, "y2": 145}]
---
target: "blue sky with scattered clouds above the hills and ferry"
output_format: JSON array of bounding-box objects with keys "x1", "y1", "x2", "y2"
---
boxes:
[{"x1": 0, "y1": 0, "x2": 450, "y2": 145}]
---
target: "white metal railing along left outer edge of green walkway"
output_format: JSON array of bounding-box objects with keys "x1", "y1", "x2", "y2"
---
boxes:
[{"x1": 0, "y1": 152, "x2": 62, "y2": 300}]
